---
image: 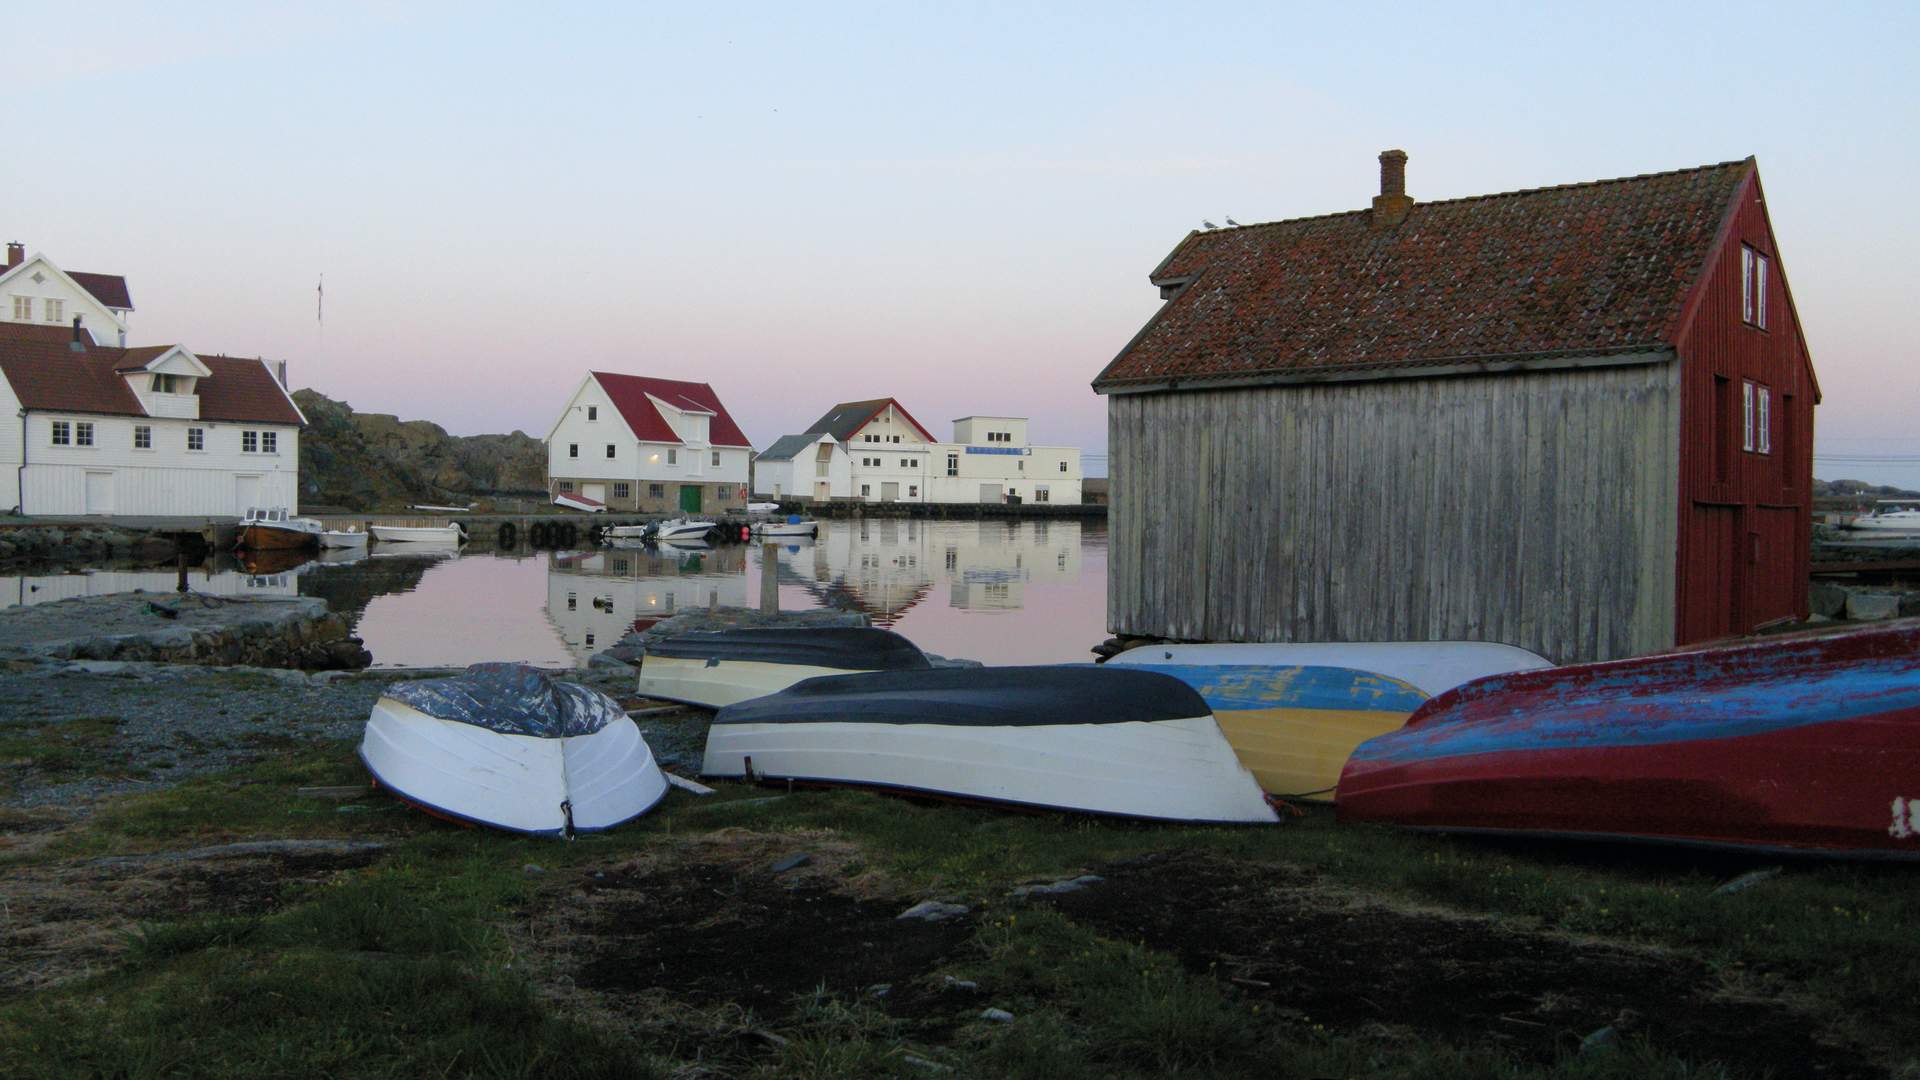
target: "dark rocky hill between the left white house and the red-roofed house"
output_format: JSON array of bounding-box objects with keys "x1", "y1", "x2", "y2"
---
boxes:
[{"x1": 294, "y1": 390, "x2": 547, "y2": 509}]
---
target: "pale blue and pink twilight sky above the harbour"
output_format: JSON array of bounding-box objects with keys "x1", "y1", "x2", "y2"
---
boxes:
[{"x1": 11, "y1": 2, "x2": 1920, "y2": 478}]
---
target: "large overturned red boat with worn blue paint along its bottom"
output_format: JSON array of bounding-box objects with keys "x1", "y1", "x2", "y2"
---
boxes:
[{"x1": 1338, "y1": 621, "x2": 1920, "y2": 859}]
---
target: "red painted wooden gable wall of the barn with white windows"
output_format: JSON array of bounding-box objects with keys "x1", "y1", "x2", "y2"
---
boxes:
[{"x1": 1672, "y1": 173, "x2": 1818, "y2": 644}]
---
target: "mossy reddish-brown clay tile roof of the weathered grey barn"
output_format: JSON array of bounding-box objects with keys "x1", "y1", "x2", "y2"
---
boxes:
[{"x1": 1094, "y1": 158, "x2": 1753, "y2": 392}]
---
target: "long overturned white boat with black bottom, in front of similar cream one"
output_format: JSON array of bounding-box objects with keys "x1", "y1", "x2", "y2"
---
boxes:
[{"x1": 701, "y1": 667, "x2": 1277, "y2": 822}]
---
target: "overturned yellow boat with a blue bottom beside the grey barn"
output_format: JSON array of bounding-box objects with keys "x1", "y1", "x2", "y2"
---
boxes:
[{"x1": 1106, "y1": 650, "x2": 1427, "y2": 801}]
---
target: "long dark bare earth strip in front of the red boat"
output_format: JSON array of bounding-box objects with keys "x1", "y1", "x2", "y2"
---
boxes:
[{"x1": 1048, "y1": 853, "x2": 1885, "y2": 1080}]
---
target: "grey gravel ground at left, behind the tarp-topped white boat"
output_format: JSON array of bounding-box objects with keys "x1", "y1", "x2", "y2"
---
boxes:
[{"x1": 0, "y1": 661, "x2": 683, "y2": 809}]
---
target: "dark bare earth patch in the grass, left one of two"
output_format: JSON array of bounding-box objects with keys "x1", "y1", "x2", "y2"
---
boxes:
[{"x1": 560, "y1": 865, "x2": 973, "y2": 1017}]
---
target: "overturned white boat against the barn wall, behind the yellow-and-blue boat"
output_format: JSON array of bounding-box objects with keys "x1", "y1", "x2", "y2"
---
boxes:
[{"x1": 1106, "y1": 642, "x2": 1553, "y2": 698}]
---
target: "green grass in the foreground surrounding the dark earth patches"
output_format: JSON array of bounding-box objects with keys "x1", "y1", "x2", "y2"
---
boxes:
[{"x1": 0, "y1": 734, "x2": 1920, "y2": 1080}]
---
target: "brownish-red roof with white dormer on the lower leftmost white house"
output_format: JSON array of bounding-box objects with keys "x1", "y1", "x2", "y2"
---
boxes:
[{"x1": 0, "y1": 336, "x2": 301, "y2": 425}]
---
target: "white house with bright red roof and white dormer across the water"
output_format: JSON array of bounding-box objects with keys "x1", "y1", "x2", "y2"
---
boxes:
[{"x1": 547, "y1": 371, "x2": 753, "y2": 513}]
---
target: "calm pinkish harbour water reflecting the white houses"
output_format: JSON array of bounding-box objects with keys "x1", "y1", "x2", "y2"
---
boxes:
[{"x1": 0, "y1": 519, "x2": 1106, "y2": 667}]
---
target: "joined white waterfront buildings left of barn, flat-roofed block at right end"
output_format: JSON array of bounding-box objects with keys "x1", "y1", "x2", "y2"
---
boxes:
[{"x1": 756, "y1": 398, "x2": 1083, "y2": 503}]
